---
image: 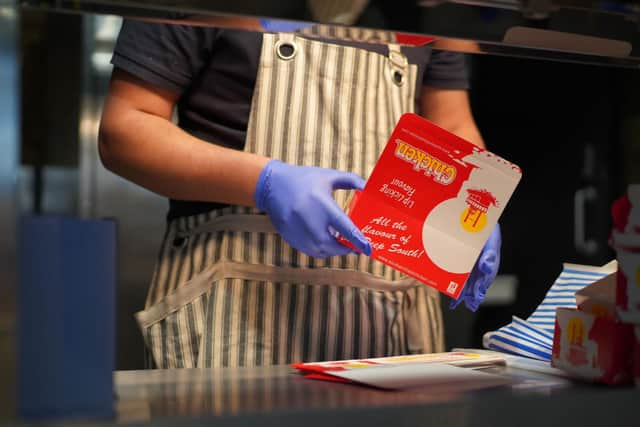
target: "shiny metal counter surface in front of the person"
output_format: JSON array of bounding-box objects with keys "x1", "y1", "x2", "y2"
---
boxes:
[{"x1": 109, "y1": 366, "x2": 640, "y2": 427}]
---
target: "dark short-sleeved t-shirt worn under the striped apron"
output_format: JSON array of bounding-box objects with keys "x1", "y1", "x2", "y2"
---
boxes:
[{"x1": 111, "y1": 20, "x2": 468, "y2": 219}]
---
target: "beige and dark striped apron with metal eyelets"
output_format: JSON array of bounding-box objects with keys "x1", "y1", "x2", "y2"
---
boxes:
[{"x1": 136, "y1": 33, "x2": 444, "y2": 368}]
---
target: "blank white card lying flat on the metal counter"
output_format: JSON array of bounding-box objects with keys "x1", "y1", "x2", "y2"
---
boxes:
[{"x1": 331, "y1": 363, "x2": 512, "y2": 390}]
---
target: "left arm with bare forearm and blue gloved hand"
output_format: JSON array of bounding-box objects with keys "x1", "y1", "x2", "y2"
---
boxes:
[{"x1": 99, "y1": 69, "x2": 371, "y2": 257}]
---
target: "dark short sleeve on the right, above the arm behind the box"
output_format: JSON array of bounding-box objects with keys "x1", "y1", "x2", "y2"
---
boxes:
[{"x1": 422, "y1": 50, "x2": 469, "y2": 89}]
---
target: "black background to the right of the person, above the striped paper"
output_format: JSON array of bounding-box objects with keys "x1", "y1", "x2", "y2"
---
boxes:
[{"x1": 462, "y1": 56, "x2": 640, "y2": 345}]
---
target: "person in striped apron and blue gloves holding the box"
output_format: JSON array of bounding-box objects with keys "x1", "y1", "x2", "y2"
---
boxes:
[{"x1": 99, "y1": 12, "x2": 500, "y2": 368}]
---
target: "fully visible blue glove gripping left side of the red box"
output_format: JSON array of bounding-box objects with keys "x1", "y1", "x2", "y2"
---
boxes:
[{"x1": 254, "y1": 160, "x2": 371, "y2": 258}]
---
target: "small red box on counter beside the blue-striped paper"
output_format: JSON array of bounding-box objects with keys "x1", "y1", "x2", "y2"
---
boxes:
[{"x1": 551, "y1": 307, "x2": 634, "y2": 385}]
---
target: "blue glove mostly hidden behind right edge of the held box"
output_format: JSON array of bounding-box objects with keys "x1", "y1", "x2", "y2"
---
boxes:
[{"x1": 449, "y1": 224, "x2": 502, "y2": 311}]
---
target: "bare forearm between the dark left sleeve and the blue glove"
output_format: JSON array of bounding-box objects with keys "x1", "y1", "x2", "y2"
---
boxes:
[{"x1": 99, "y1": 68, "x2": 269, "y2": 206}]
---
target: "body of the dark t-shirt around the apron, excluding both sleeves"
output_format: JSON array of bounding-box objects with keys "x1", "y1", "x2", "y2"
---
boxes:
[{"x1": 168, "y1": 29, "x2": 431, "y2": 219}]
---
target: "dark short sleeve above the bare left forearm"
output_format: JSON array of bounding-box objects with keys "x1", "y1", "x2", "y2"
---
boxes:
[{"x1": 111, "y1": 20, "x2": 217, "y2": 93}]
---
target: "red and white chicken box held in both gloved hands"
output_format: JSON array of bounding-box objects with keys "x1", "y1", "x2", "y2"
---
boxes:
[{"x1": 343, "y1": 114, "x2": 522, "y2": 299}]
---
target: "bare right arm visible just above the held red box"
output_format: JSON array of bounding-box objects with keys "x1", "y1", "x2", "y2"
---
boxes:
[{"x1": 421, "y1": 86, "x2": 485, "y2": 148}]
